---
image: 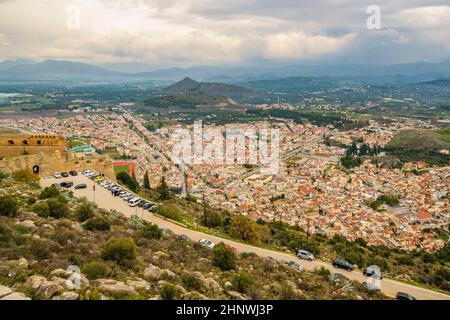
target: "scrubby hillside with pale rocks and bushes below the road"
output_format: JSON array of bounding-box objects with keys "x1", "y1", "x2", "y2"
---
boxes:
[{"x1": 0, "y1": 175, "x2": 385, "y2": 300}]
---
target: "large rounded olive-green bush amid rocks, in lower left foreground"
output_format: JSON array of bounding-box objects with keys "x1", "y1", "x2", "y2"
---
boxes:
[{"x1": 102, "y1": 238, "x2": 137, "y2": 265}]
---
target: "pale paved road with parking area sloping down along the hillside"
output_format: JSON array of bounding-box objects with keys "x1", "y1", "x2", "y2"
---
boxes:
[{"x1": 41, "y1": 175, "x2": 450, "y2": 300}]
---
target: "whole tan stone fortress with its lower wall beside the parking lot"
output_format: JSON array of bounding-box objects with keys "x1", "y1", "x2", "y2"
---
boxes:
[{"x1": 0, "y1": 135, "x2": 115, "y2": 179}]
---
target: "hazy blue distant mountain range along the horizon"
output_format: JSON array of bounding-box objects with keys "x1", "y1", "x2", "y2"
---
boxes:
[{"x1": 0, "y1": 60, "x2": 450, "y2": 84}]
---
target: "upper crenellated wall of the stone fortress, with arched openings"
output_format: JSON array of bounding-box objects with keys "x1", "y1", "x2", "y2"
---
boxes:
[{"x1": 0, "y1": 134, "x2": 70, "y2": 159}]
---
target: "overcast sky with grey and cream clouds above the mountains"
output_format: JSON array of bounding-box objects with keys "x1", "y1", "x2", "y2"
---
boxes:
[{"x1": 0, "y1": 0, "x2": 450, "y2": 67}]
